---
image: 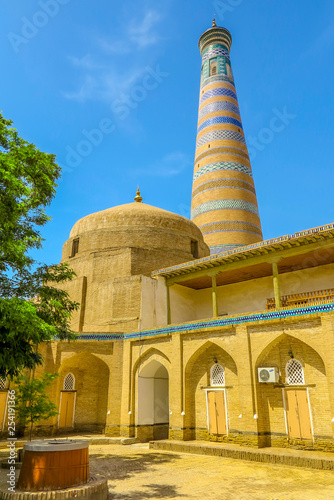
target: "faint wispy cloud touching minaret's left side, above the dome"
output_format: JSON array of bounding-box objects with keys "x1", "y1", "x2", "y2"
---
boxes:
[{"x1": 133, "y1": 151, "x2": 192, "y2": 177}]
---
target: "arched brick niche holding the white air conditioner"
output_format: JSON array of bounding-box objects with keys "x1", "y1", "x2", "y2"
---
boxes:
[{"x1": 255, "y1": 333, "x2": 332, "y2": 446}]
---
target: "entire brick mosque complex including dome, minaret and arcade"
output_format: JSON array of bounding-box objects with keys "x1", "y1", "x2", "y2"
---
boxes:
[{"x1": 0, "y1": 19, "x2": 334, "y2": 449}]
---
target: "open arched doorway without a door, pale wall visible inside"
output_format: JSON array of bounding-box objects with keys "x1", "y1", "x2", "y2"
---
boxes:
[{"x1": 137, "y1": 360, "x2": 169, "y2": 441}]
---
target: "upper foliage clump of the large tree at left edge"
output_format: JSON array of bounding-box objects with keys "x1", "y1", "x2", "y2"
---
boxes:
[{"x1": 0, "y1": 113, "x2": 61, "y2": 272}]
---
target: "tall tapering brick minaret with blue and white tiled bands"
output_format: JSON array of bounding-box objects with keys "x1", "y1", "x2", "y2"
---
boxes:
[{"x1": 191, "y1": 19, "x2": 263, "y2": 254}]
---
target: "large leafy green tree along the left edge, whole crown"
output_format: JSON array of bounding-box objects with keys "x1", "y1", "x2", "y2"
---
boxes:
[{"x1": 0, "y1": 113, "x2": 78, "y2": 377}]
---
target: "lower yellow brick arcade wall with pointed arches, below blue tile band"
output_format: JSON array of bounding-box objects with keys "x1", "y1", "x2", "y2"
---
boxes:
[{"x1": 21, "y1": 313, "x2": 334, "y2": 449}]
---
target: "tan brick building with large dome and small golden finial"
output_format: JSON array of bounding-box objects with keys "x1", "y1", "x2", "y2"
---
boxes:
[{"x1": 62, "y1": 191, "x2": 210, "y2": 333}]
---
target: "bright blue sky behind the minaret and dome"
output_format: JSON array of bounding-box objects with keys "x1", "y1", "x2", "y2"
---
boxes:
[{"x1": 0, "y1": 0, "x2": 334, "y2": 264}]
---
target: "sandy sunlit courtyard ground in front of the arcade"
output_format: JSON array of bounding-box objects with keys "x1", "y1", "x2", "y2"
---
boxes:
[{"x1": 0, "y1": 444, "x2": 334, "y2": 500}]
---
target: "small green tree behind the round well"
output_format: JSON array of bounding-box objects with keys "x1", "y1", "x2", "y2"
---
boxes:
[{"x1": 15, "y1": 373, "x2": 58, "y2": 441}]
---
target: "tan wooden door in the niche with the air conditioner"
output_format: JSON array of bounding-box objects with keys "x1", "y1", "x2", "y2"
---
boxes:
[{"x1": 285, "y1": 389, "x2": 313, "y2": 439}]
